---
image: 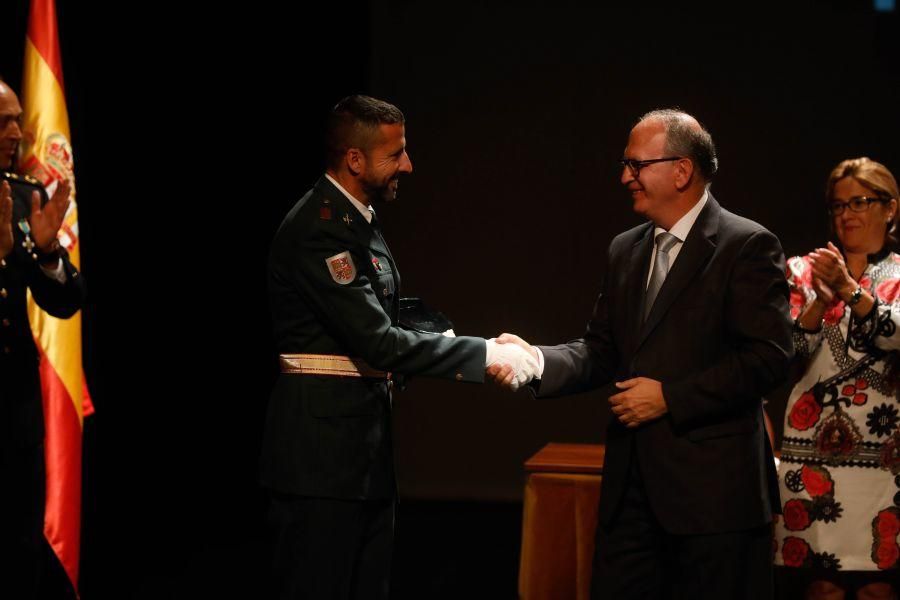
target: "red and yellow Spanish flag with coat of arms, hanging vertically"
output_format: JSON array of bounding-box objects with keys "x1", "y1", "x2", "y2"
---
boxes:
[{"x1": 21, "y1": 0, "x2": 93, "y2": 593}]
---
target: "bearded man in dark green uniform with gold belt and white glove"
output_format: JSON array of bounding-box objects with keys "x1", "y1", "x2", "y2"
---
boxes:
[{"x1": 261, "y1": 96, "x2": 537, "y2": 599}]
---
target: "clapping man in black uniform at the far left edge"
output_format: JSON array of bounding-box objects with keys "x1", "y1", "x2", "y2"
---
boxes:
[{"x1": 0, "y1": 81, "x2": 85, "y2": 598}]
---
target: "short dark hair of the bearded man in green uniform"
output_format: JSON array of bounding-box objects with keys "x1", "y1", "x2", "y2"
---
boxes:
[{"x1": 325, "y1": 94, "x2": 406, "y2": 167}]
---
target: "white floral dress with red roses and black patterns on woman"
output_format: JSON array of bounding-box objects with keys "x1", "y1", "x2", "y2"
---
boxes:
[{"x1": 775, "y1": 253, "x2": 900, "y2": 571}]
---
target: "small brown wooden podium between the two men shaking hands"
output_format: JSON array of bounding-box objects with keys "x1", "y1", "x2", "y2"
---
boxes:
[{"x1": 519, "y1": 444, "x2": 606, "y2": 600}]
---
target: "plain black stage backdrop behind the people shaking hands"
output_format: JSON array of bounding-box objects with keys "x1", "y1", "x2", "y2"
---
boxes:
[{"x1": 0, "y1": 0, "x2": 900, "y2": 600}]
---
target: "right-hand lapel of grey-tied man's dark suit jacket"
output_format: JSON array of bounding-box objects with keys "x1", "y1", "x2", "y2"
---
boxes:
[{"x1": 635, "y1": 194, "x2": 721, "y2": 350}]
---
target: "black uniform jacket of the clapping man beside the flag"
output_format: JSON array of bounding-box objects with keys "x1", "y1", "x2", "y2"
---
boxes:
[{"x1": 0, "y1": 171, "x2": 85, "y2": 446}]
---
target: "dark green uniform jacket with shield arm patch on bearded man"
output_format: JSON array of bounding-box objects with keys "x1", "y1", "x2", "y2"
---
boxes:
[{"x1": 261, "y1": 177, "x2": 485, "y2": 499}]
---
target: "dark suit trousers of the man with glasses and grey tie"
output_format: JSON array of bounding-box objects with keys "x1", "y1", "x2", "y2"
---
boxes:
[{"x1": 591, "y1": 446, "x2": 774, "y2": 600}]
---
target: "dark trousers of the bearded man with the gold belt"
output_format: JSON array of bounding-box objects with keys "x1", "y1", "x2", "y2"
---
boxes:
[{"x1": 268, "y1": 491, "x2": 396, "y2": 600}]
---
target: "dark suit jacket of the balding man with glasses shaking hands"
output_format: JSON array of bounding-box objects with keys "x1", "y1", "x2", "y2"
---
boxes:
[{"x1": 538, "y1": 195, "x2": 793, "y2": 534}]
